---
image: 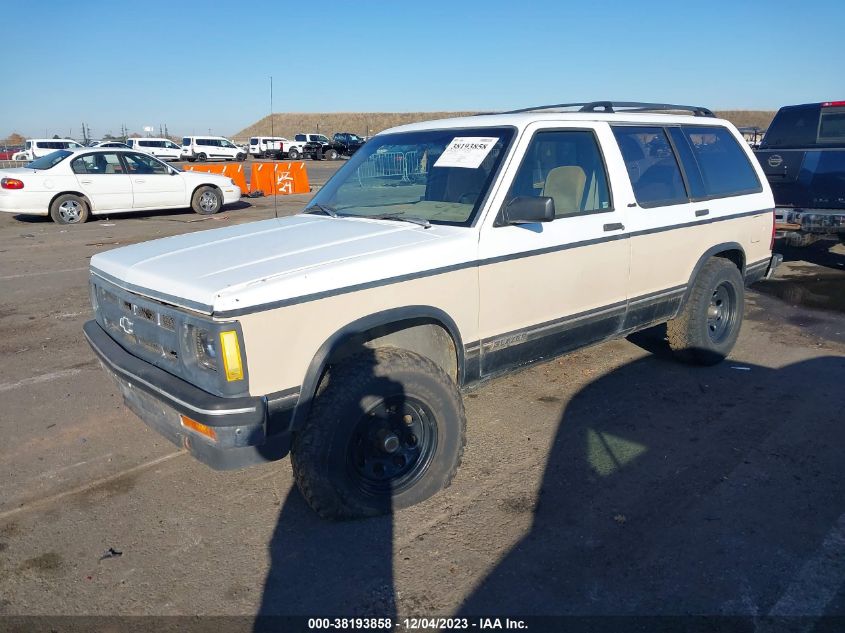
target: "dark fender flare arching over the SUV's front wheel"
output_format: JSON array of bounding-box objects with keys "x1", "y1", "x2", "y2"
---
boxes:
[{"x1": 291, "y1": 305, "x2": 464, "y2": 431}]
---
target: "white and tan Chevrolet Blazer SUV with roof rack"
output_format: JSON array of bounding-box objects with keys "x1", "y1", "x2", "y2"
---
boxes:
[{"x1": 85, "y1": 102, "x2": 779, "y2": 517}]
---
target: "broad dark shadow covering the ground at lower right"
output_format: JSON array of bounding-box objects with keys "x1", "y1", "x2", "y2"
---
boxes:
[{"x1": 460, "y1": 354, "x2": 845, "y2": 630}]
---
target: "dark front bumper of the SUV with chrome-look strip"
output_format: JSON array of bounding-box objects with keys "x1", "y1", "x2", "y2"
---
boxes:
[{"x1": 83, "y1": 321, "x2": 299, "y2": 470}]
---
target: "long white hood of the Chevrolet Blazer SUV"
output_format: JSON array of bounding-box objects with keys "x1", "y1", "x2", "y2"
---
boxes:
[{"x1": 91, "y1": 215, "x2": 477, "y2": 314}]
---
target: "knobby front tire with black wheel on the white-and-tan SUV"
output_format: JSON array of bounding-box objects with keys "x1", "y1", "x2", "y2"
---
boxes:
[{"x1": 291, "y1": 348, "x2": 466, "y2": 519}]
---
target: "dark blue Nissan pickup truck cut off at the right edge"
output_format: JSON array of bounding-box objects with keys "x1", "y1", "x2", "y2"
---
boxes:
[{"x1": 754, "y1": 101, "x2": 845, "y2": 246}]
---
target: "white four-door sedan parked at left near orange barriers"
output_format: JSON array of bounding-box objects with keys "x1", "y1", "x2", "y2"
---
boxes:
[{"x1": 0, "y1": 148, "x2": 241, "y2": 224}]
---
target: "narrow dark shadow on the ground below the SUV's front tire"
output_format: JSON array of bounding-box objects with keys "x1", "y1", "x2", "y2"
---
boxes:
[{"x1": 254, "y1": 347, "x2": 404, "y2": 633}]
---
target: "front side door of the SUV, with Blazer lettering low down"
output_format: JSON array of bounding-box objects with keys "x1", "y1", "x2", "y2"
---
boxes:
[{"x1": 479, "y1": 124, "x2": 630, "y2": 376}]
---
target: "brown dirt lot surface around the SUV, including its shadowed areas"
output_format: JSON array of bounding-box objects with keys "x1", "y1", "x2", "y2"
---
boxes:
[{"x1": 0, "y1": 180, "x2": 845, "y2": 630}]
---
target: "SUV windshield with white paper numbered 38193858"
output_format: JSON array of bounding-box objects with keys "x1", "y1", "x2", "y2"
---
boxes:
[{"x1": 311, "y1": 128, "x2": 514, "y2": 226}]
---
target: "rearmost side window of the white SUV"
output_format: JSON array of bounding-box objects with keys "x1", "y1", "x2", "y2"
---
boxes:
[{"x1": 681, "y1": 125, "x2": 761, "y2": 196}]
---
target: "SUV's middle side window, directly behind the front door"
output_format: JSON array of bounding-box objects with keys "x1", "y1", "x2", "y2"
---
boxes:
[{"x1": 613, "y1": 125, "x2": 688, "y2": 207}]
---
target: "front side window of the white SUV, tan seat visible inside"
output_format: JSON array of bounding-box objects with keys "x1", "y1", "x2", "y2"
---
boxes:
[{"x1": 507, "y1": 130, "x2": 611, "y2": 217}]
